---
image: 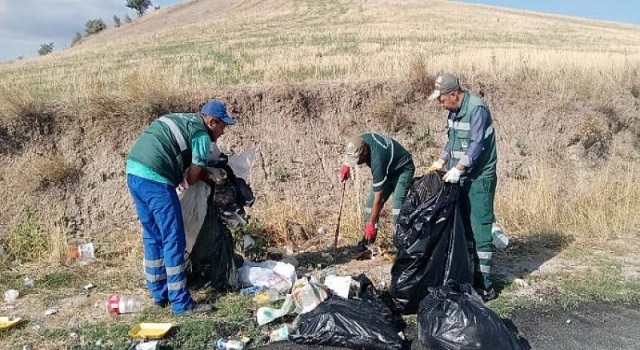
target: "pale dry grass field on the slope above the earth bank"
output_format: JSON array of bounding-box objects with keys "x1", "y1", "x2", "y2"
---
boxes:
[{"x1": 0, "y1": 0, "x2": 640, "y2": 109}]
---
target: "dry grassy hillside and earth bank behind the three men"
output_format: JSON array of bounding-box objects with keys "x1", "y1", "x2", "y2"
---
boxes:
[{"x1": 0, "y1": 0, "x2": 640, "y2": 347}]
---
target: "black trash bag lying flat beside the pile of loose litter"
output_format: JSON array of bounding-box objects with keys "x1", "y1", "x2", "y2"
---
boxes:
[{"x1": 289, "y1": 275, "x2": 404, "y2": 350}]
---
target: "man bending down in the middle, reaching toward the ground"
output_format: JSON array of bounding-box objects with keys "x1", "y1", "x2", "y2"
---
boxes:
[{"x1": 340, "y1": 133, "x2": 415, "y2": 251}]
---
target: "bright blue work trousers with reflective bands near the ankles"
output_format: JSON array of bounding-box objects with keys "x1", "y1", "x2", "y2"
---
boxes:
[{"x1": 127, "y1": 174, "x2": 193, "y2": 314}]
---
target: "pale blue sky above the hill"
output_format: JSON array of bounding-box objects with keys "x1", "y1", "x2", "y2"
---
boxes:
[{"x1": 0, "y1": 0, "x2": 640, "y2": 62}]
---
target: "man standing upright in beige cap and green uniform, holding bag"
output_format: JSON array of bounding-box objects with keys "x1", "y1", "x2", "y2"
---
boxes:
[{"x1": 427, "y1": 73, "x2": 498, "y2": 301}]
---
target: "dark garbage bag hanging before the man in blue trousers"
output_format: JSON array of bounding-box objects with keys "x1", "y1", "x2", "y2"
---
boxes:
[{"x1": 187, "y1": 186, "x2": 243, "y2": 291}]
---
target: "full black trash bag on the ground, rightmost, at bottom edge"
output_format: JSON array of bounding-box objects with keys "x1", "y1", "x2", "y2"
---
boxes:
[{"x1": 418, "y1": 284, "x2": 521, "y2": 350}]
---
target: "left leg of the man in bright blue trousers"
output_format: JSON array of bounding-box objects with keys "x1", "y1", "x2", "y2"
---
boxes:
[{"x1": 127, "y1": 175, "x2": 169, "y2": 304}]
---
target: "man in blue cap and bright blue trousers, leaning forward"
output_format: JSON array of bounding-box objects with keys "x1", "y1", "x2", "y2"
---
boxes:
[{"x1": 126, "y1": 101, "x2": 236, "y2": 315}]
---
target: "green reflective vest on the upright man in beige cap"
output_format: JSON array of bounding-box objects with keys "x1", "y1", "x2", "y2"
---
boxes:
[{"x1": 447, "y1": 92, "x2": 498, "y2": 182}]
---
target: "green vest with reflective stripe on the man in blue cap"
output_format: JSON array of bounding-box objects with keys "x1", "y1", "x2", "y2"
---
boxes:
[{"x1": 127, "y1": 113, "x2": 207, "y2": 186}]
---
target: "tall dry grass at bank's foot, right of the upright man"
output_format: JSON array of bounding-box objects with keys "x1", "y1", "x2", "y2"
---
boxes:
[{"x1": 496, "y1": 154, "x2": 640, "y2": 250}]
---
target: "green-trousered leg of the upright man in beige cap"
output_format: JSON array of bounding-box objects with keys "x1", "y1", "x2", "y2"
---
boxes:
[{"x1": 465, "y1": 178, "x2": 497, "y2": 291}]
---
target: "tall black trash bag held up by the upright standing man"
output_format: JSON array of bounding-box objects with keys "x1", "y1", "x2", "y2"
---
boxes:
[{"x1": 389, "y1": 173, "x2": 473, "y2": 314}]
